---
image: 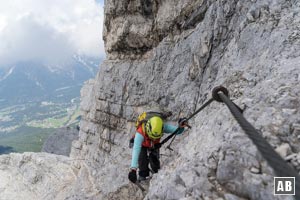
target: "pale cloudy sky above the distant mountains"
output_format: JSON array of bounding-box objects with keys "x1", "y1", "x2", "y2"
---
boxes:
[{"x1": 0, "y1": 0, "x2": 105, "y2": 66}]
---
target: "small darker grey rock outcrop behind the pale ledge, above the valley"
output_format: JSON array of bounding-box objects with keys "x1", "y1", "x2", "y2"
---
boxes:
[{"x1": 42, "y1": 127, "x2": 79, "y2": 156}]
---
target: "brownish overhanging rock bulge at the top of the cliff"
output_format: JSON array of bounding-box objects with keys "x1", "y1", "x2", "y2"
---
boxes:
[{"x1": 103, "y1": 0, "x2": 211, "y2": 59}]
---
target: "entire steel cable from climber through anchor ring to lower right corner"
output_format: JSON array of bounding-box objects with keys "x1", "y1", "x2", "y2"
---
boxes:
[{"x1": 131, "y1": 86, "x2": 300, "y2": 197}]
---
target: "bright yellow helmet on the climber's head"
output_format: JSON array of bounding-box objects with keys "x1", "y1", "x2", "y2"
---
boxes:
[{"x1": 146, "y1": 116, "x2": 163, "y2": 140}]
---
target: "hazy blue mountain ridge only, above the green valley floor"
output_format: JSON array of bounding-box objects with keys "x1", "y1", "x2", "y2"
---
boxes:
[{"x1": 0, "y1": 55, "x2": 101, "y2": 106}]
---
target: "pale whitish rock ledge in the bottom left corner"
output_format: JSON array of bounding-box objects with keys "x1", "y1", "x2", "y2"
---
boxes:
[{"x1": 0, "y1": 153, "x2": 76, "y2": 200}]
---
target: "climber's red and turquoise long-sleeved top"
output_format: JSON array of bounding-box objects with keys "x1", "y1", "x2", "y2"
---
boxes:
[{"x1": 131, "y1": 123, "x2": 184, "y2": 169}]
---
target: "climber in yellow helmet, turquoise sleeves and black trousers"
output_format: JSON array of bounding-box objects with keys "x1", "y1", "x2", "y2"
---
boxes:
[{"x1": 128, "y1": 116, "x2": 188, "y2": 183}]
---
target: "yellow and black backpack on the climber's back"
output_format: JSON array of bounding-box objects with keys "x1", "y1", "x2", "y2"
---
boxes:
[{"x1": 129, "y1": 111, "x2": 172, "y2": 148}]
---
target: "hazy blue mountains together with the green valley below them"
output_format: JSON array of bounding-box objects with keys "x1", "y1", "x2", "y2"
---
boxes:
[{"x1": 0, "y1": 55, "x2": 102, "y2": 154}]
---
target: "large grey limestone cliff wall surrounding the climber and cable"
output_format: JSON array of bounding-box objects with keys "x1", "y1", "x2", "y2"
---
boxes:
[{"x1": 0, "y1": 0, "x2": 300, "y2": 200}]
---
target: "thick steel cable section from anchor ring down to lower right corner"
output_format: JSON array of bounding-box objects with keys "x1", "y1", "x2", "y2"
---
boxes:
[{"x1": 213, "y1": 86, "x2": 300, "y2": 199}]
